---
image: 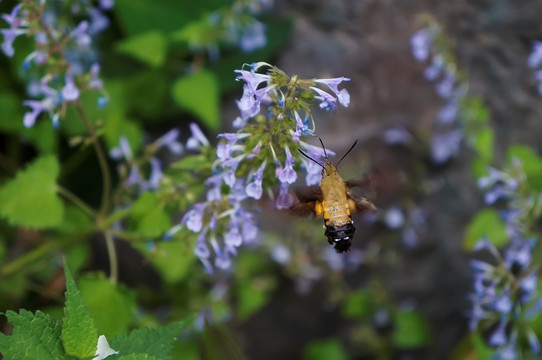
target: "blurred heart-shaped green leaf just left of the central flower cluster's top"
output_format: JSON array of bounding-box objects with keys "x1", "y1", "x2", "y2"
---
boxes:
[{"x1": 172, "y1": 70, "x2": 220, "y2": 131}]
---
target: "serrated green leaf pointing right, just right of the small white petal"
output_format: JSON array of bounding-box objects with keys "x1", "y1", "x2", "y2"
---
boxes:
[{"x1": 110, "y1": 317, "x2": 193, "y2": 359}]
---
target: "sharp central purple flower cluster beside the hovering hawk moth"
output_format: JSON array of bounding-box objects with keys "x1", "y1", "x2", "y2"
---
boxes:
[{"x1": 170, "y1": 62, "x2": 350, "y2": 272}]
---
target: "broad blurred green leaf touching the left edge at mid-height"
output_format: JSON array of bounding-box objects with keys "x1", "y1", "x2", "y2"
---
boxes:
[{"x1": 0, "y1": 155, "x2": 64, "y2": 228}]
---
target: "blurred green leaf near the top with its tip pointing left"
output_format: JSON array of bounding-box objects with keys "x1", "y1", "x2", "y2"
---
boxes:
[{"x1": 115, "y1": 31, "x2": 167, "y2": 68}]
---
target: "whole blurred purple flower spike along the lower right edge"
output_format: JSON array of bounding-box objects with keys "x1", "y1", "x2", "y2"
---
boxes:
[{"x1": 471, "y1": 158, "x2": 542, "y2": 359}]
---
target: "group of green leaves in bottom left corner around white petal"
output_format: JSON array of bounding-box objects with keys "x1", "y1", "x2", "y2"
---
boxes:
[{"x1": 0, "y1": 262, "x2": 193, "y2": 360}]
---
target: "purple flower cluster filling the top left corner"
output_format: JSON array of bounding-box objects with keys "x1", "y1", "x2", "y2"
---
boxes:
[{"x1": 0, "y1": 0, "x2": 113, "y2": 128}]
